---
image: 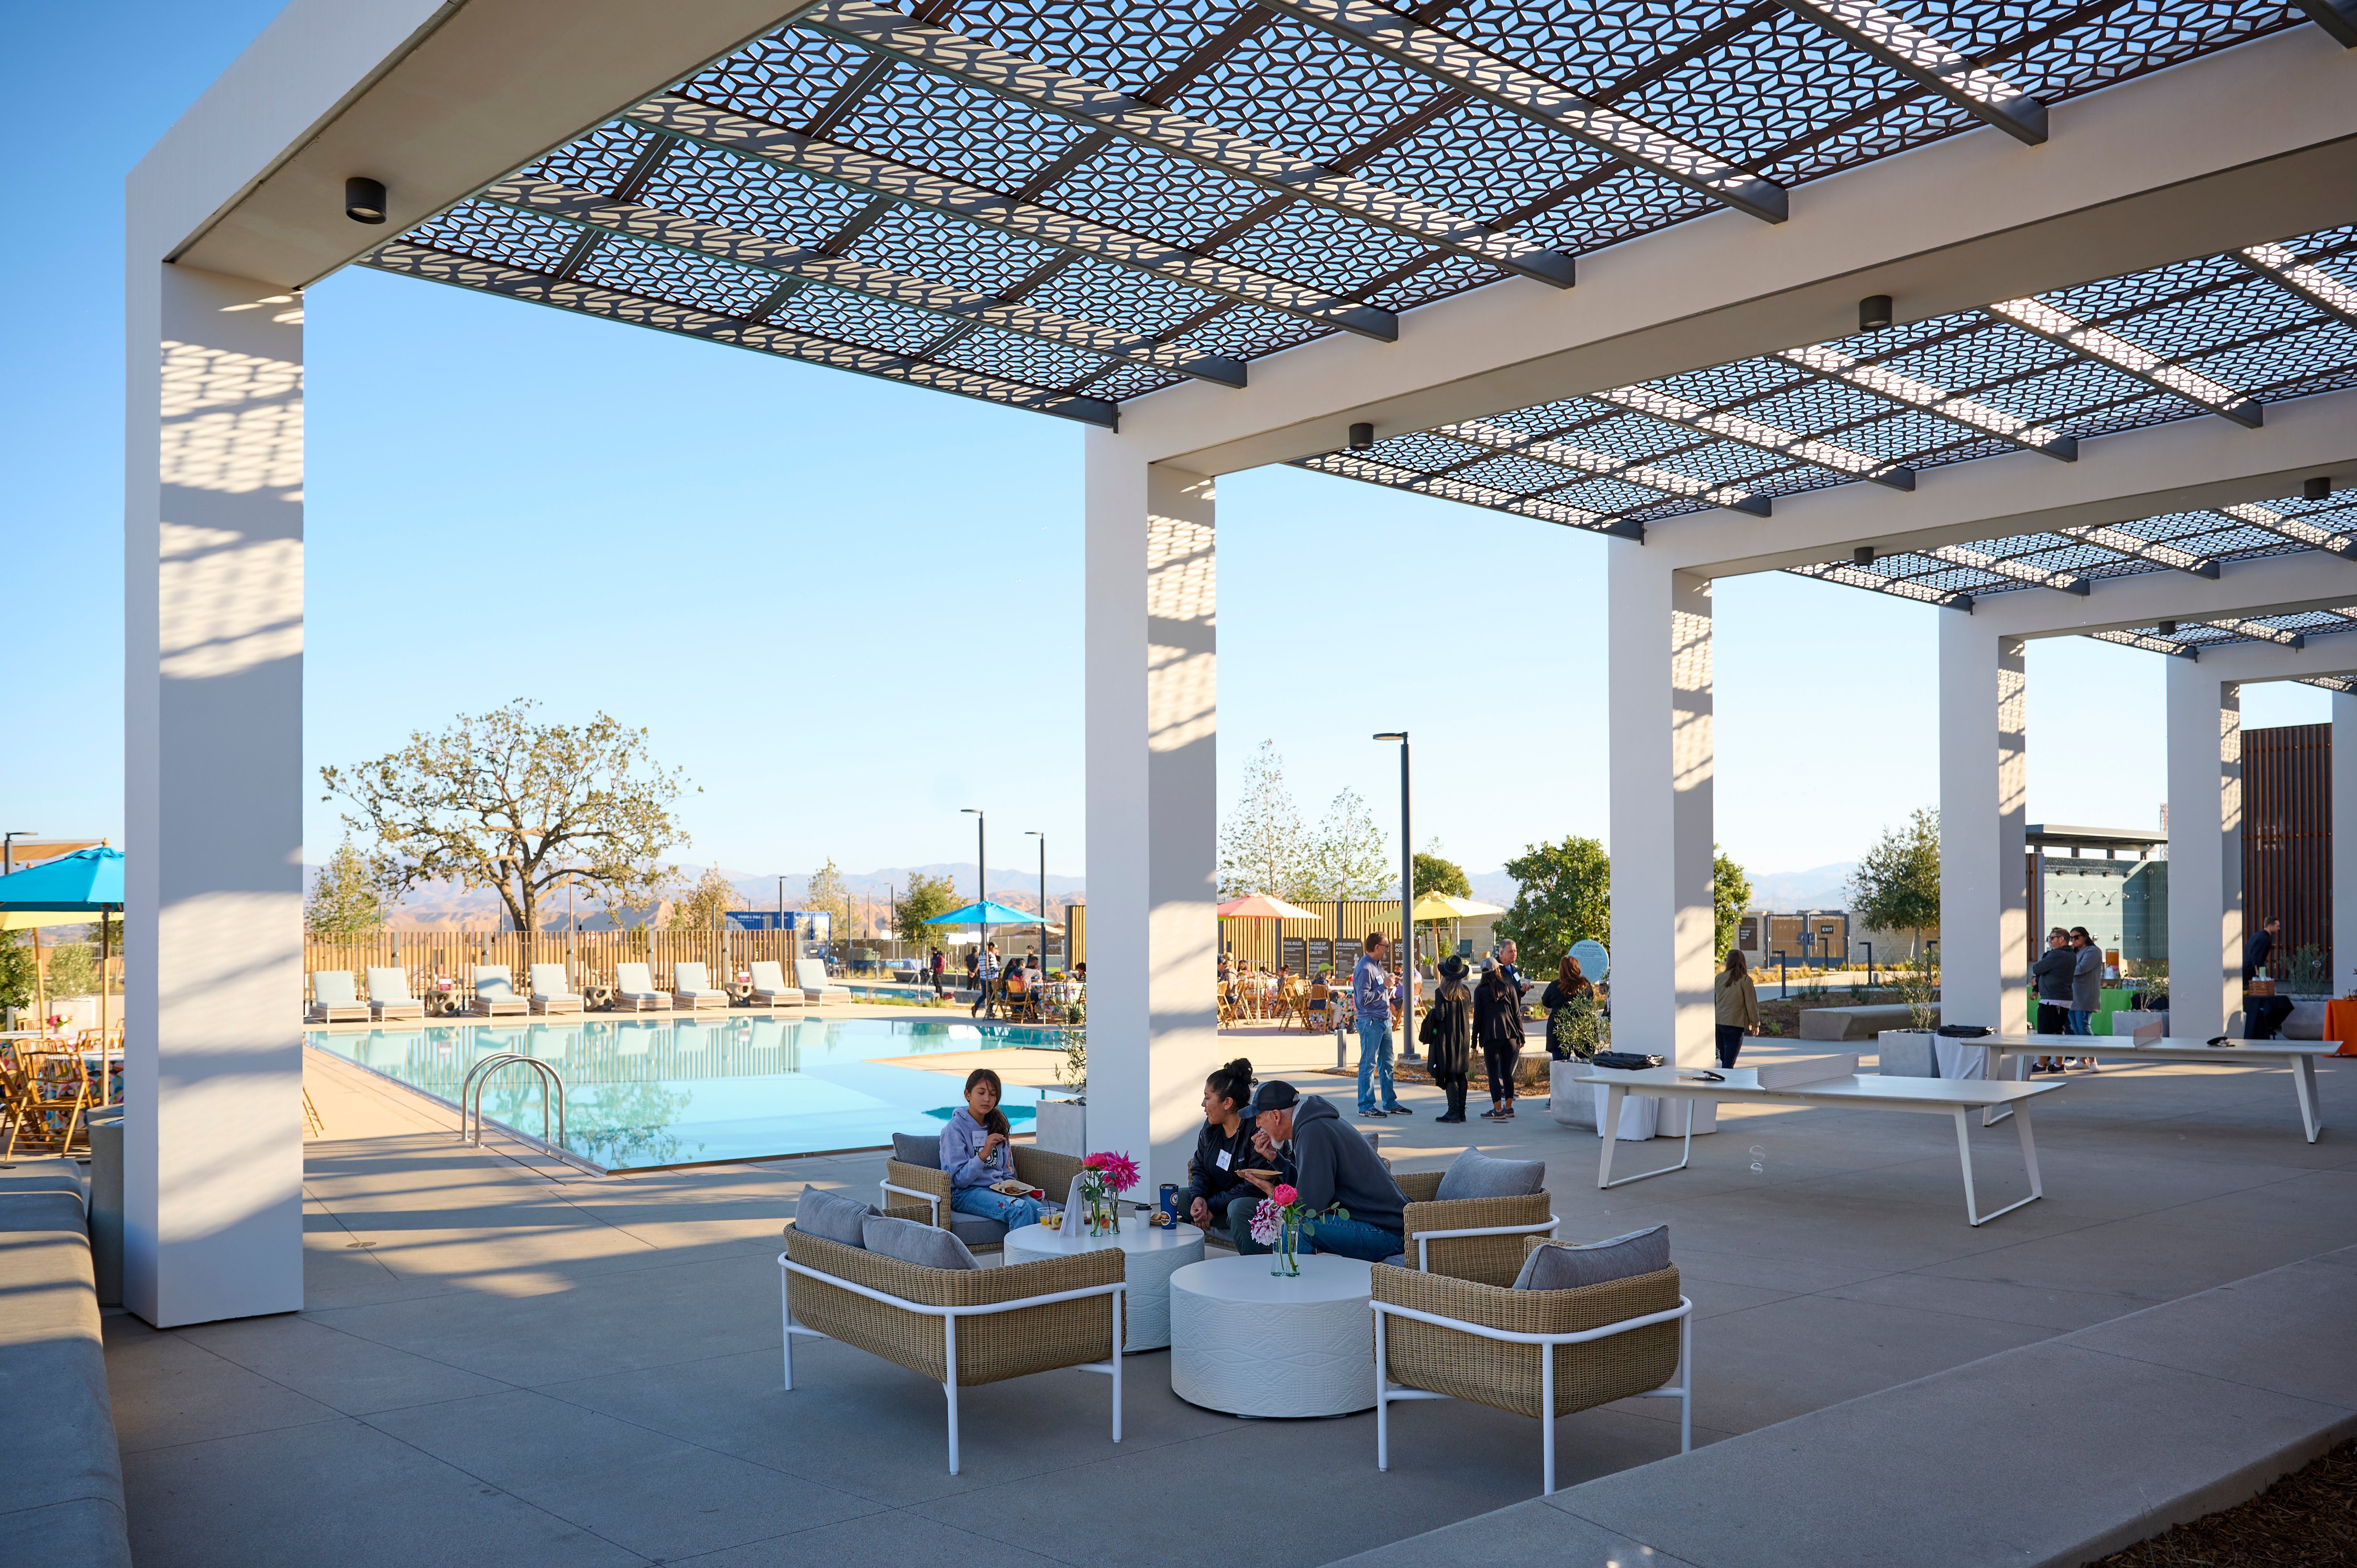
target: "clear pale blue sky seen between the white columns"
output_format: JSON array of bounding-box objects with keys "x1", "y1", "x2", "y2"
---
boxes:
[{"x1": 0, "y1": 0, "x2": 2327, "y2": 891}]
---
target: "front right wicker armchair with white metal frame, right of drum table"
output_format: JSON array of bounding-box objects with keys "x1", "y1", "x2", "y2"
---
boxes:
[{"x1": 1372, "y1": 1238, "x2": 1695, "y2": 1493}]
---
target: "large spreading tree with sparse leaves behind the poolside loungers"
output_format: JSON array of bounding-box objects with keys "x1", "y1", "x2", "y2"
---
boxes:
[{"x1": 318, "y1": 698, "x2": 691, "y2": 931}]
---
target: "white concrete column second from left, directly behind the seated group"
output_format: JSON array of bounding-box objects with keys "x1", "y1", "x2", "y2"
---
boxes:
[{"x1": 1087, "y1": 429, "x2": 1226, "y2": 1181}]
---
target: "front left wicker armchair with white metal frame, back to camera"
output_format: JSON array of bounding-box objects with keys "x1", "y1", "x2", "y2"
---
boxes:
[{"x1": 778, "y1": 1224, "x2": 1127, "y2": 1476}]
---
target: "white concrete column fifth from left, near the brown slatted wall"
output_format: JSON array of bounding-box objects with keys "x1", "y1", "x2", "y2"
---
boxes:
[{"x1": 2168, "y1": 658, "x2": 2242, "y2": 1040}]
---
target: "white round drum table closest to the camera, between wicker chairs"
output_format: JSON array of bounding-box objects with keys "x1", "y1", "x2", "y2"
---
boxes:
[{"x1": 1169, "y1": 1252, "x2": 1374, "y2": 1415}]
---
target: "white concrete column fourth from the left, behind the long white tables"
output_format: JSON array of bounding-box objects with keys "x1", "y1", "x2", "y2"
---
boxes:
[{"x1": 1940, "y1": 613, "x2": 2030, "y2": 1035}]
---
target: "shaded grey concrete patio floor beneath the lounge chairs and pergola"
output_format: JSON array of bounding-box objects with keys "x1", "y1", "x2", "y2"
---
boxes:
[{"x1": 106, "y1": 1032, "x2": 2357, "y2": 1568}]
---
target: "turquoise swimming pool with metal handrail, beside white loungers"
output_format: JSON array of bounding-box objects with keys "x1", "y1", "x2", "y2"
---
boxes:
[{"x1": 304, "y1": 1016, "x2": 1059, "y2": 1169}]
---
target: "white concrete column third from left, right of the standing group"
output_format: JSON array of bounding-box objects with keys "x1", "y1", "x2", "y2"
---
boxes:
[{"x1": 1605, "y1": 543, "x2": 1716, "y2": 1070}]
